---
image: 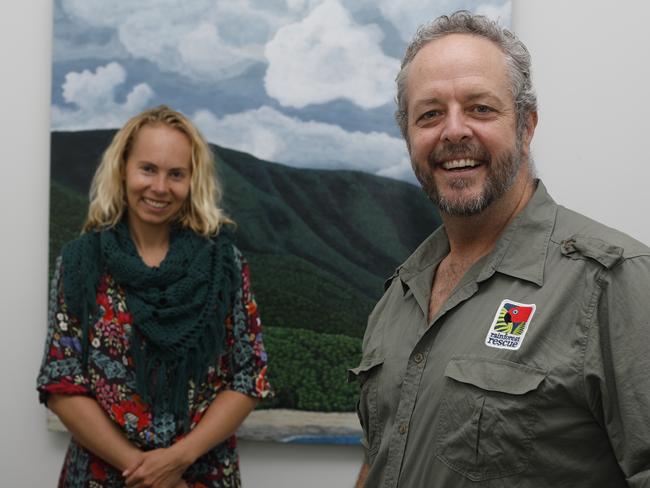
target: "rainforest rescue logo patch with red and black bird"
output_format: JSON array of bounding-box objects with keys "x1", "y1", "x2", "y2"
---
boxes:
[{"x1": 485, "y1": 299, "x2": 535, "y2": 350}]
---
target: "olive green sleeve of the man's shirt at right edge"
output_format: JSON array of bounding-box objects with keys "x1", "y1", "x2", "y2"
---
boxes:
[{"x1": 585, "y1": 256, "x2": 650, "y2": 488}]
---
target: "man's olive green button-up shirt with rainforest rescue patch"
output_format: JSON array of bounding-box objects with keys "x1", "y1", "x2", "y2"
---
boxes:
[{"x1": 350, "y1": 182, "x2": 650, "y2": 488}]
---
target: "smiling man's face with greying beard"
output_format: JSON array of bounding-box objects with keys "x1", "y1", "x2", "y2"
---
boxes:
[{"x1": 406, "y1": 34, "x2": 534, "y2": 216}]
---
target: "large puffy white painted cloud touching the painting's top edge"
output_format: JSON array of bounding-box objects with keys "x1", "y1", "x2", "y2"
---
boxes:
[{"x1": 264, "y1": 0, "x2": 399, "y2": 108}]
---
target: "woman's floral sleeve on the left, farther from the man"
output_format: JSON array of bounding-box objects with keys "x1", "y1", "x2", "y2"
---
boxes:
[{"x1": 36, "y1": 257, "x2": 91, "y2": 404}]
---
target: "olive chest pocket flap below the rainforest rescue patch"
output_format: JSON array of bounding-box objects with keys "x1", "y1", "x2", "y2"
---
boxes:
[{"x1": 445, "y1": 357, "x2": 548, "y2": 395}]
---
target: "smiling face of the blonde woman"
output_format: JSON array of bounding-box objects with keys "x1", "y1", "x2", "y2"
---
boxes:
[{"x1": 124, "y1": 124, "x2": 192, "y2": 232}]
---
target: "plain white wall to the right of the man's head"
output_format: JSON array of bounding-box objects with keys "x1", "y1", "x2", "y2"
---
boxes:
[{"x1": 513, "y1": 0, "x2": 650, "y2": 243}]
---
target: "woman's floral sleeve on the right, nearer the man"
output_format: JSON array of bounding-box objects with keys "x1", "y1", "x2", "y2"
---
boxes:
[{"x1": 221, "y1": 249, "x2": 272, "y2": 399}]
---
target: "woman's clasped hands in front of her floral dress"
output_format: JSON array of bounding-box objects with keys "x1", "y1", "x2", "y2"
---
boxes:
[{"x1": 122, "y1": 444, "x2": 192, "y2": 488}]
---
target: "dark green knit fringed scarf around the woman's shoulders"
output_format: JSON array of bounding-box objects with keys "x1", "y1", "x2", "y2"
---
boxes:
[{"x1": 62, "y1": 221, "x2": 240, "y2": 429}]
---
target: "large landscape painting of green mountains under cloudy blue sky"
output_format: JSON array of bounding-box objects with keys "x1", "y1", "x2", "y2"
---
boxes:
[{"x1": 50, "y1": 0, "x2": 511, "y2": 443}]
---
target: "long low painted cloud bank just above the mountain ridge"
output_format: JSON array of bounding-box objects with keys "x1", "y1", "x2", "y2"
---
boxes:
[{"x1": 192, "y1": 107, "x2": 414, "y2": 181}]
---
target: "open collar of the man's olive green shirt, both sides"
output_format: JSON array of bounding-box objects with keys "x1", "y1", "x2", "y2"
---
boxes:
[{"x1": 398, "y1": 180, "x2": 557, "y2": 292}]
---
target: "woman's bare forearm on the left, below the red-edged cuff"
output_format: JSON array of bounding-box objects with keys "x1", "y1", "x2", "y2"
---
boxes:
[{"x1": 47, "y1": 395, "x2": 142, "y2": 472}]
